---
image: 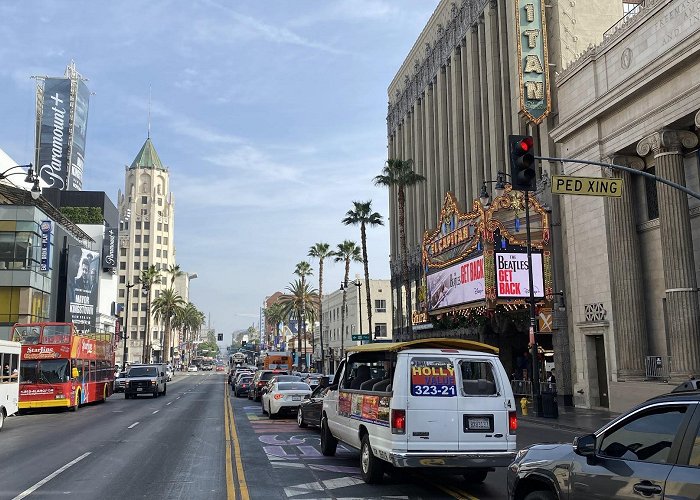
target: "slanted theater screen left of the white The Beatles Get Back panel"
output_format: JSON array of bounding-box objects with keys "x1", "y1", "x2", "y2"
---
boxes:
[{"x1": 427, "y1": 255, "x2": 486, "y2": 311}]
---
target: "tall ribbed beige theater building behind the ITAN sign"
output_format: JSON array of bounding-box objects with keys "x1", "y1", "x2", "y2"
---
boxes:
[{"x1": 387, "y1": 0, "x2": 636, "y2": 403}]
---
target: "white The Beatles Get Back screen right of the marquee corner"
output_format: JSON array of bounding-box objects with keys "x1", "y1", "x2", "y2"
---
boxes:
[{"x1": 496, "y1": 252, "x2": 544, "y2": 298}]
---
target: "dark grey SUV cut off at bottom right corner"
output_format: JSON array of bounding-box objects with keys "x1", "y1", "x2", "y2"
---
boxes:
[{"x1": 508, "y1": 384, "x2": 700, "y2": 500}]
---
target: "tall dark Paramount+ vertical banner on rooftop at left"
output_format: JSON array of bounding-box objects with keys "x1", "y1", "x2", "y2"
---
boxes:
[{"x1": 37, "y1": 78, "x2": 71, "y2": 190}]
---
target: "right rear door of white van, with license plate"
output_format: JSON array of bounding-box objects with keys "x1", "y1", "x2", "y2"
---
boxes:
[{"x1": 455, "y1": 355, "x2": 515, "y2": 451}]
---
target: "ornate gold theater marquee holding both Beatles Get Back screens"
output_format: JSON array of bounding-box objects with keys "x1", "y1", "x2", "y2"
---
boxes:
[{"x1": 413, "y1": 186, "x2": 553, "y2": 330}]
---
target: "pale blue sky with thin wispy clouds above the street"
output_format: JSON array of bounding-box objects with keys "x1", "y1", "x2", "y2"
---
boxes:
[{"x1": 0, "y1": 0, "x2": 438, "y2": 333}]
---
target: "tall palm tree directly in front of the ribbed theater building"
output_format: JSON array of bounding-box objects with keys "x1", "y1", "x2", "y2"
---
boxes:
[{"x1": 374, "y1": 158, "x2": 425, "y2": 335}]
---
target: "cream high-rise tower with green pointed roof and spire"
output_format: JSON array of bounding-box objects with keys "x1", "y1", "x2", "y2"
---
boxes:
[{"x1": 118, "y1": 137, "x2": 175, "y2": 362}]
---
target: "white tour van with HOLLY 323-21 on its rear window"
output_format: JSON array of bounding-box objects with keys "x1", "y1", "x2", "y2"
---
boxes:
[{"x1": 321, "y1": 338, "x2": 517, "y2": 483}]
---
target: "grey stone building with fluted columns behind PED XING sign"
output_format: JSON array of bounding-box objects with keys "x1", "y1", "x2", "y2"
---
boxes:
[{"x1": 551, "y1": 0, "x2": 700, "y2": 411}]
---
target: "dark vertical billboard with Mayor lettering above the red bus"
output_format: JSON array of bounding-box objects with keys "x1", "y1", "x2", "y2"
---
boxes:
[{"x1": 66, "y1": 246, "x2": 100, "y2": 331}]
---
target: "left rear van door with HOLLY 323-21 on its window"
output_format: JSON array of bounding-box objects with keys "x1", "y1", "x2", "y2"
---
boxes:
[{"x1": 406, "y1": 353, "x2": 460, "y2": 451}]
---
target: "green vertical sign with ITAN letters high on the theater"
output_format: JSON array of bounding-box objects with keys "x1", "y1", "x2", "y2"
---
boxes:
[{"x1": 515, "y1": 0, "x2": 552, "y2": 124}]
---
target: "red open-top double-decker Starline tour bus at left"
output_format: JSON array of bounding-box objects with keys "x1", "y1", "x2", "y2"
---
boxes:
[{"x1": 12, "y1": 323, "x2": 114, "y2": 411}]
